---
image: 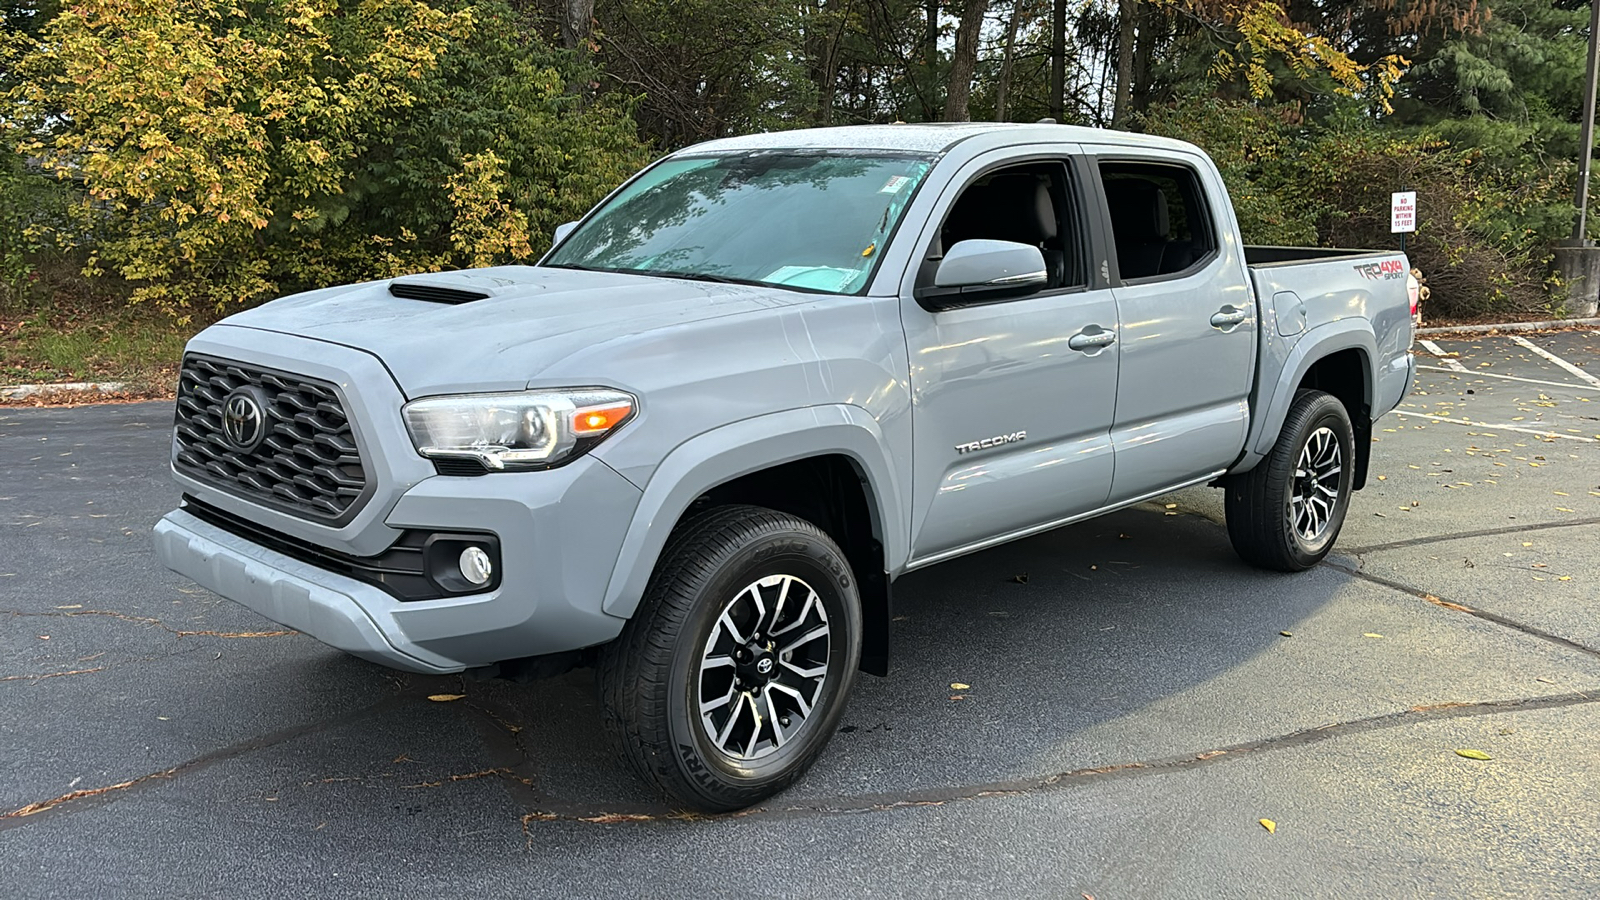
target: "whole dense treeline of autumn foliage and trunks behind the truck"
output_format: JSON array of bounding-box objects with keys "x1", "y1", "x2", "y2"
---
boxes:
[{"x1": 0, "y1": 0, "x2": 1589, "y2": 314}]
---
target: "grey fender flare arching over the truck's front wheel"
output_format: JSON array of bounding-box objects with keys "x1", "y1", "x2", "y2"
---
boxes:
[{"x1": 603, "y1": 404, "x2": 909, "y2": 618}]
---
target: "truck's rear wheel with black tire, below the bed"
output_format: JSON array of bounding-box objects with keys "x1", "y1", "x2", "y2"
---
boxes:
[{"x1": 1226, "y1": 391, "x2": 1355, "y2": 572}]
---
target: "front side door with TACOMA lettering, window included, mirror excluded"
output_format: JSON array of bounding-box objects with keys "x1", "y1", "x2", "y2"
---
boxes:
[{"x1": 901, "y1": 147, "x2": 1118, "y2": 565}]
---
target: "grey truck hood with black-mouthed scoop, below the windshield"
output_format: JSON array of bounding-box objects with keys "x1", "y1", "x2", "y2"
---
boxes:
[{"x1": 221, "y1": 266, "x2": 814, "y2": 397}]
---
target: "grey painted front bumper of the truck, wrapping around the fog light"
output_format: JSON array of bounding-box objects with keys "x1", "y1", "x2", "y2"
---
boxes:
[{"x1": 155, "y1": 458, "x2": 640, "y2": 673}]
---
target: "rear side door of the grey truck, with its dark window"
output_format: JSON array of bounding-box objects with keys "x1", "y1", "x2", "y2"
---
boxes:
[{"x1": 1090, "y1": 147, "x2": 1256, "y2": 503}]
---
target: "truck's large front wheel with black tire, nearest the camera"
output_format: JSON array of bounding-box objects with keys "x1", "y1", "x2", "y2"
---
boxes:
[{"x1": 598, "y1": 506, "x2": 861, "y2": 812}]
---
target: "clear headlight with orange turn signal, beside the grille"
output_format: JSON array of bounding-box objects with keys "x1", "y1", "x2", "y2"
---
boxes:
[{"x1": 402, "y1": 388, "x2": 635, "y2": 469}]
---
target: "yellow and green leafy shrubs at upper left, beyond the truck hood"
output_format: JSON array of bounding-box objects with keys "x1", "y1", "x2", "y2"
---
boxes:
[{"x1": 0, "y1": 0, "x2": 643, "y2": 314}]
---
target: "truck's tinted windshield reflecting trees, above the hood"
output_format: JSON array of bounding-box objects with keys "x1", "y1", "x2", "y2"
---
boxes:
[{"x1": 544, "y1": 151, "x2": 933, "y2": 293}]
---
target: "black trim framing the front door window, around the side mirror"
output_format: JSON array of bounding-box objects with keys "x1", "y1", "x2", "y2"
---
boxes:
[{"x1": 912, "y1": 151, "x2": 1104, "y2": 312}]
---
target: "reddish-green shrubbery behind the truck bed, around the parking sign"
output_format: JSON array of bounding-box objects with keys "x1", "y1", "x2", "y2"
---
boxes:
[{"x1": 1146, "y1": 101, "x2": 1573, "y2": 317}]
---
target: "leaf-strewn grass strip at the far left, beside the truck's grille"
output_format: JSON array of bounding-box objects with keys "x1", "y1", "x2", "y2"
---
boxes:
[{"x1": 0, "y1": 304, "x2": 203, "y2": 394}]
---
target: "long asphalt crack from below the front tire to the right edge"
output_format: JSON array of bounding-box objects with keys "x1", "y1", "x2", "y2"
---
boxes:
[{"x1": 522, "y1": 690, "x2": 1600, "y2": 839}]
